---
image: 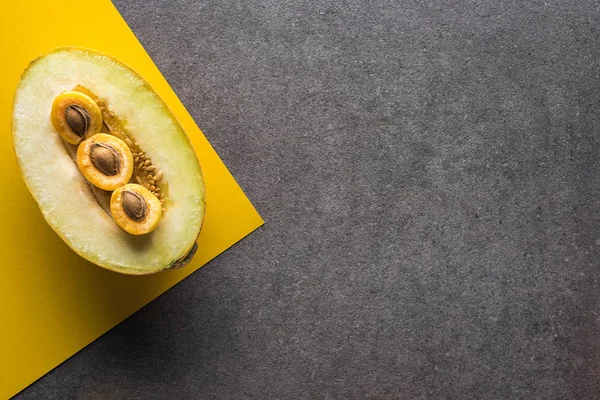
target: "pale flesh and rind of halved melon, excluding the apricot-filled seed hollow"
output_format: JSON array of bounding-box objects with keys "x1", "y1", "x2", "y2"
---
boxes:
[{"x1": 12, "y1": 48, "x2": 206, "y2": 275}]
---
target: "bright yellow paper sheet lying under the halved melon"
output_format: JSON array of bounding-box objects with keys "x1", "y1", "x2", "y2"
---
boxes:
[{"x1": 0, "y1": 0, "x2": 263, "y2": 398}]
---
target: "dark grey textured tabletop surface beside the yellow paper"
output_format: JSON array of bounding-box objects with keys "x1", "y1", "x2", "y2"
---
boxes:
[{"x1": 12, "y1": 0, "x2": 600, "y2": 399}]
